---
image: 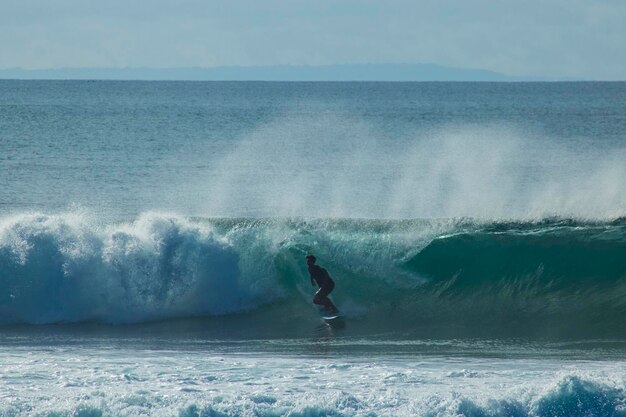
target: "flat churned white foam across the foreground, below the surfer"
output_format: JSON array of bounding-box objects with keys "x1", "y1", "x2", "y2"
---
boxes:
[{"x1": 0, "y1": 340, "x2": 626, "y2": 417}]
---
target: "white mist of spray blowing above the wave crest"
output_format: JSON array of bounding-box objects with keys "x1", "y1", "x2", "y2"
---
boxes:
[{"x1": 189, "y1": 114, "x2": 626, "y2": 219}]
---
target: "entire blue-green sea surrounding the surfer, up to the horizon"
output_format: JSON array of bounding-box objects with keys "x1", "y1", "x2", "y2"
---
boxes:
[{"x1": 0, "y1": 80, "x2": 626, "y2": 417}]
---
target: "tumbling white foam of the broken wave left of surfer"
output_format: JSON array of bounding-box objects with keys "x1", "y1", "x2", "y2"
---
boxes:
[{"x1": 0, "y1": 213, "x2": 272, "y2": 323}]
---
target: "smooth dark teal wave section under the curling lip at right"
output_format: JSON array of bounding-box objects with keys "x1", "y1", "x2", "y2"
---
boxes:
[{"x1": 406, "y1": 219, "x2": 626, "y2": 287}]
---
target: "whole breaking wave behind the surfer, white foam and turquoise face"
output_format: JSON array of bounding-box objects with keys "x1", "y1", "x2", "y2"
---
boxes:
[{"x1": 0, "y1": 213, "x2": 626, "y2": 336}]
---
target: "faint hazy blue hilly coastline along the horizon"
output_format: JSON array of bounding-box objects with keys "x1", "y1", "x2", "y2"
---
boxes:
[{"x1": 0, "y1": 64, "x2": 539, "y2": 81}]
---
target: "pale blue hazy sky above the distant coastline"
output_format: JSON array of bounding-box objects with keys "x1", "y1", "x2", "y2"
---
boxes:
[{"x1": 0, "y1": 0, "x2": 626, "y2": 80}]
